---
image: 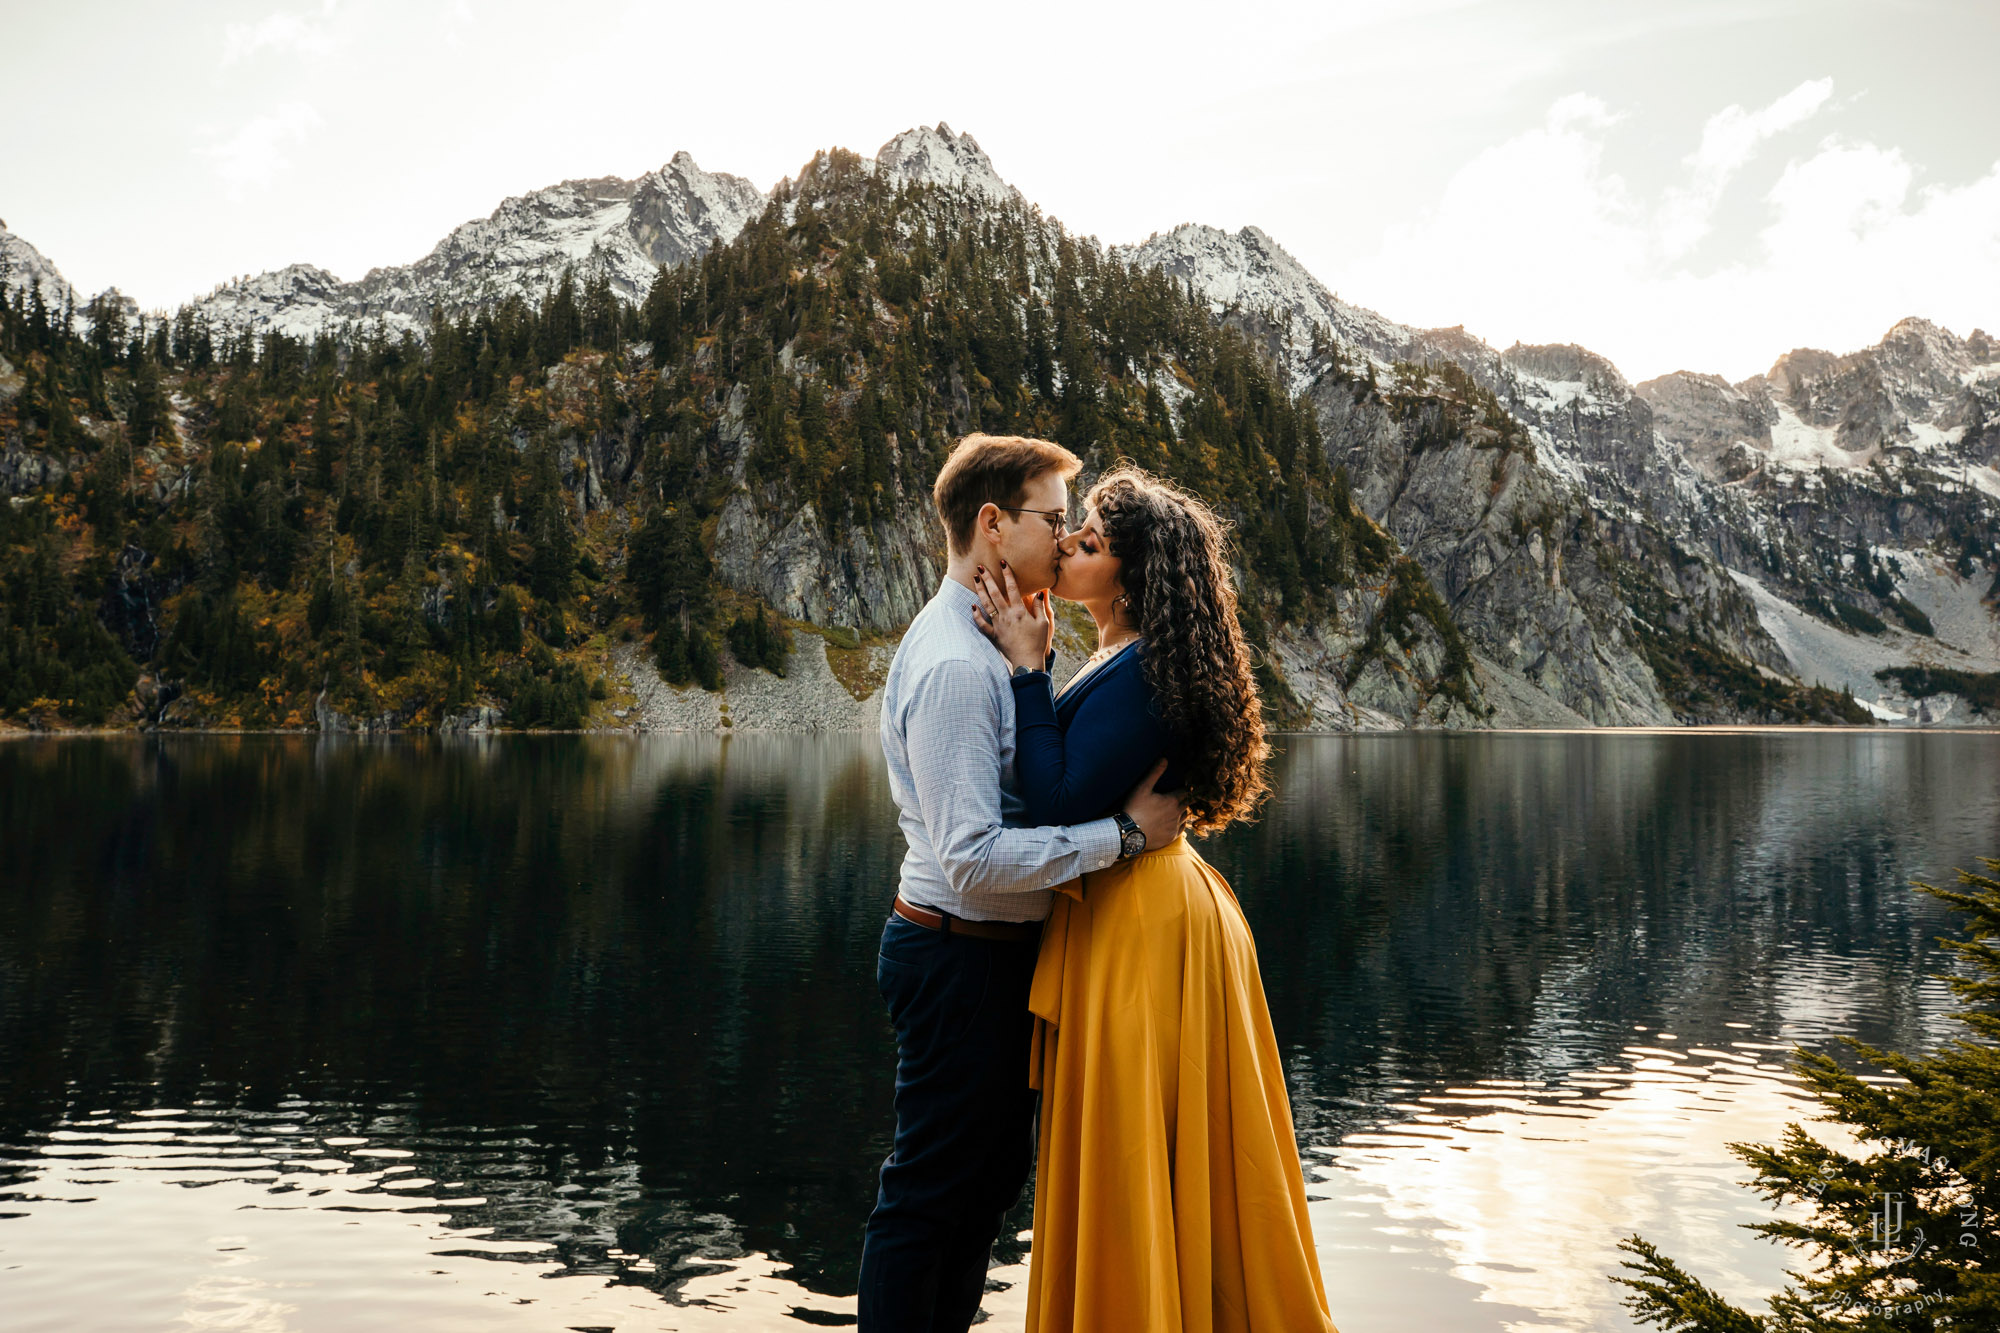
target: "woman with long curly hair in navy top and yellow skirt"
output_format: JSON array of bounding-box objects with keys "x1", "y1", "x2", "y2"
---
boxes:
[{"x1": 978, "y1": 468, "x2": 1334, "y2": 1333}]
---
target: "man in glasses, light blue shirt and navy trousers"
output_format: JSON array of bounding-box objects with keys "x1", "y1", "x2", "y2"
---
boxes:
[{"x1": 860, "y1": 434, "x2": 1182, "y2": 1333}]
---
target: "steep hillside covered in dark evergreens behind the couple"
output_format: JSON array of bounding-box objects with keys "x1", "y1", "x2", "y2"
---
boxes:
[{"x1": 0, "y1": 150, "x2": 1478, "y2": 727}]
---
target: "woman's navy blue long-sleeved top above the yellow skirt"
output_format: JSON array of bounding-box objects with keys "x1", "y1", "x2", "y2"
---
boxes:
[{"x1": 1012, "y1": 642, "x2": 1182, "y2": 827}]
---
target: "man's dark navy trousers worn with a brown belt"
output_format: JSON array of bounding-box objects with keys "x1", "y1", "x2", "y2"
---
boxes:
[{"x1": 860, "y1": 915, "x2": 1036, "y2": 1333}]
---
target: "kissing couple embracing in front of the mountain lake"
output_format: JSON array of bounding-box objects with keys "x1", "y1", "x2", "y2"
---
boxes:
[{"x1": 860, "y1": 434, "x2": 1334, "y2": 1333}]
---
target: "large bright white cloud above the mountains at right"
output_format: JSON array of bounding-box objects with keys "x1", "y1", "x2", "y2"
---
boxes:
[{"x1": 1346, "y1": 80, "x2": 2000, "y2": 378}]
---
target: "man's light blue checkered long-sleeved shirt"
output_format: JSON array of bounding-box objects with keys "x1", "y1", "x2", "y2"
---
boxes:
[{"x1": 882, "y1": 578, "x2": 1118, "y2": 921}]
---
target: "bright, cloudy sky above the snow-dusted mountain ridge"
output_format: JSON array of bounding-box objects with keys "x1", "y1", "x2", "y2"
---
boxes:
[{"x1": 0, "y1": 0, "x2": 2000, "y2": 380}]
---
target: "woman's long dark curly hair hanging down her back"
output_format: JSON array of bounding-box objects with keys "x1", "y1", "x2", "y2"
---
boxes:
[{"x1": 1088, "y1": 464, "x2": 1270, "y2": 835}]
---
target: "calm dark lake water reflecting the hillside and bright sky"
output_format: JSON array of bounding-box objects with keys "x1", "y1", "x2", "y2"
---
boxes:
[{"x1": 0, "y1": 733, "x2": 2000, "y2": 1333}]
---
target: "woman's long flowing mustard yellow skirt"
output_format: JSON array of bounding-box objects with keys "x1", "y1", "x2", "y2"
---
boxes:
[{"x1": 1028, "y1": 839, "x2": 1334, "y2": 1333}]
